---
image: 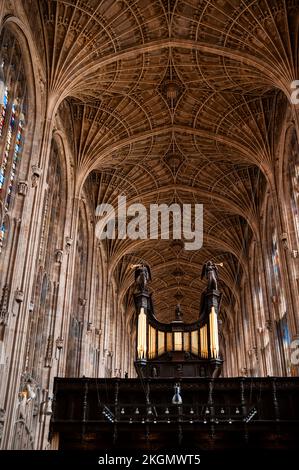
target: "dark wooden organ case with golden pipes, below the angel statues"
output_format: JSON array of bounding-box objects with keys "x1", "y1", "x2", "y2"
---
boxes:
[{"x1": 134, "y1": 278, "x2": 222, "y2": 378}]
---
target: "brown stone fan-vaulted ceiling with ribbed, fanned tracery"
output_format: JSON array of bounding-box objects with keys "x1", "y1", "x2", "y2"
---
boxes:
[{"x1": 22, "y1": 0, "x2": 298, "y2": 321}]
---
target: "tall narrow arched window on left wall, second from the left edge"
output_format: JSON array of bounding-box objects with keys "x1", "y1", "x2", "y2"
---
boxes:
[{"x1": 27, "y1": 139, "x2": 66, "y2": 378}]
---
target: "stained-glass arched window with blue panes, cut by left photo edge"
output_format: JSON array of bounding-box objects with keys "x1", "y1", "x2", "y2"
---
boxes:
[{"x1": 0, "y1": 28, "x2": 27, "y2": 252}]
